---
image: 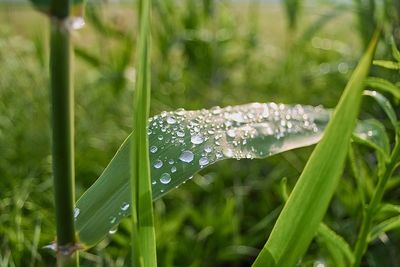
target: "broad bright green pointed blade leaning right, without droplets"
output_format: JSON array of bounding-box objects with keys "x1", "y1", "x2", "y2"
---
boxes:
[{"x1": 253, "y1": 32, "x2": 377, "y2": 267}]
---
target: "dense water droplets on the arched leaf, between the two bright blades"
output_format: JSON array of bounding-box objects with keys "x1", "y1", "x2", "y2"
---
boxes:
[{"x1": 148, "y1": 103, "x2": 330, "y2": 192}]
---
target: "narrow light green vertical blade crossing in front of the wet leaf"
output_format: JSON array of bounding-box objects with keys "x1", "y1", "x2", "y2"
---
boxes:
[{"x1": 130, "y1": 0, "x2": 157, "y2": 267}]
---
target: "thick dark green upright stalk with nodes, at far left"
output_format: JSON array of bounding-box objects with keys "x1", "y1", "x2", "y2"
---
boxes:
[{"x1": 50, "y1": 0, "x2": 78, "y2": 267}]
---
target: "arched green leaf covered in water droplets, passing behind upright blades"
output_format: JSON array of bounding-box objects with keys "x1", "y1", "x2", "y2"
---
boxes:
[{"x1": 75, "y1": 103, "x2": 377, "y2": 246}]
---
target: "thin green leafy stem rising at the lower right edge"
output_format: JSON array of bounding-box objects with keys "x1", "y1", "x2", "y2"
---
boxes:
[{"x1": 353, "y1": 139, "x2": 400, "y2": 267}]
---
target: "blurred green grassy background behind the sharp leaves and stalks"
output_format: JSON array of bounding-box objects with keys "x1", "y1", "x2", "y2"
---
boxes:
[{"x1": 0, "y1": 0, "x2": 400, "y2": 267}]
